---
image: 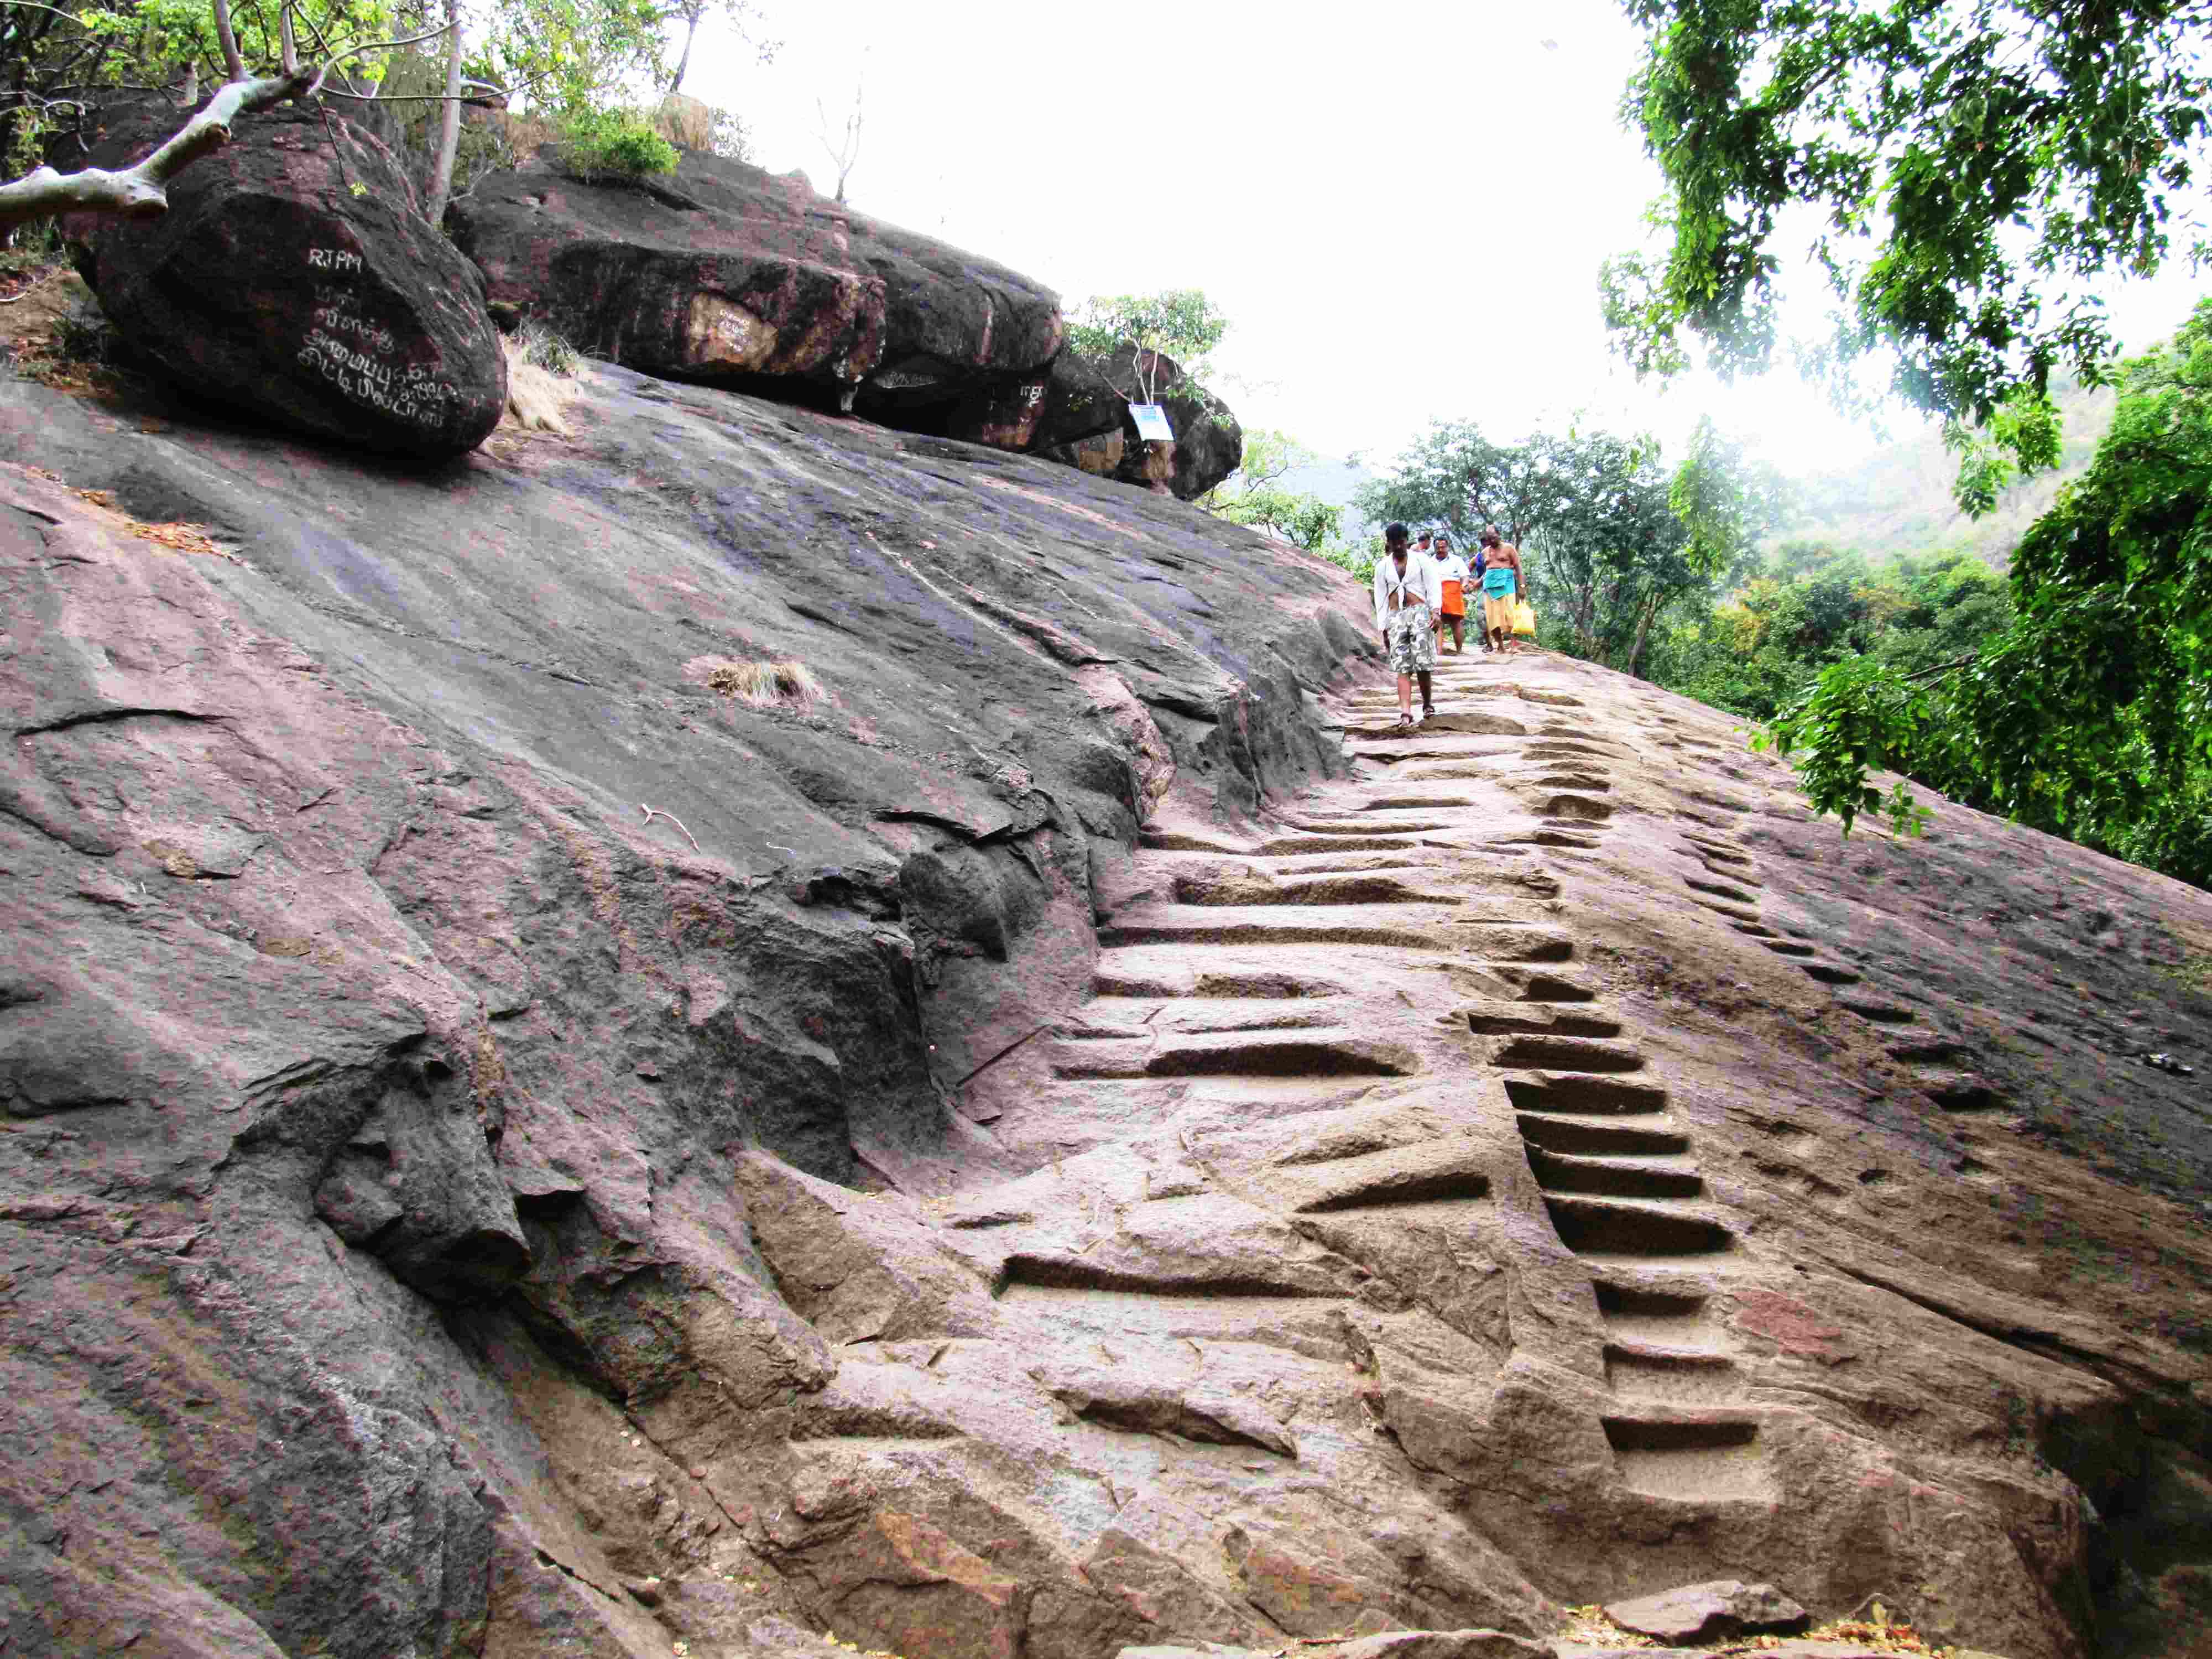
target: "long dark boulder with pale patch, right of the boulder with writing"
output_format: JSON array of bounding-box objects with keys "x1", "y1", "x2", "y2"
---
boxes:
[{"x1": 451, "y1": 146, "x2": 1064, "y2": 449}]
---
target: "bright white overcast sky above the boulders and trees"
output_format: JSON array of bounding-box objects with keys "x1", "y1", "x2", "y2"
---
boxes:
[{"x1": 684, "y1": 0, "x2": 2194, "y2": 473}]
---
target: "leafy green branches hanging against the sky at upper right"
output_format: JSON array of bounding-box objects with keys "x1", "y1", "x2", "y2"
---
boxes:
[{"x1": 1601, "y1": 0, "x2": 2212, "y2": 480}]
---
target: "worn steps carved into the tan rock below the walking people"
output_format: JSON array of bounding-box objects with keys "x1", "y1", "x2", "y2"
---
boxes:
[{"x1": 1013, "y1": 657, "x2": 1796, "y2": 1502}]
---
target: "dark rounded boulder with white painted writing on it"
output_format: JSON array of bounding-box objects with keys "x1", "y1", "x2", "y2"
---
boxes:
[{"x1": 64, "y1": 106, "x2": 507, "y2": 460}]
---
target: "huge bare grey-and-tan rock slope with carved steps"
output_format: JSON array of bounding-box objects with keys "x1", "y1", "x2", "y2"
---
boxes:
[{"x1": 0, "y1": 354, "x2": 2212, "y2": 1659}]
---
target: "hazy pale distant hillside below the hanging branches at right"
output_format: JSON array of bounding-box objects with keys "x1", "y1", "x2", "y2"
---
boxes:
[{"x1": 1776, "y1": 385, "x2": 2115, "y2": 571}]
